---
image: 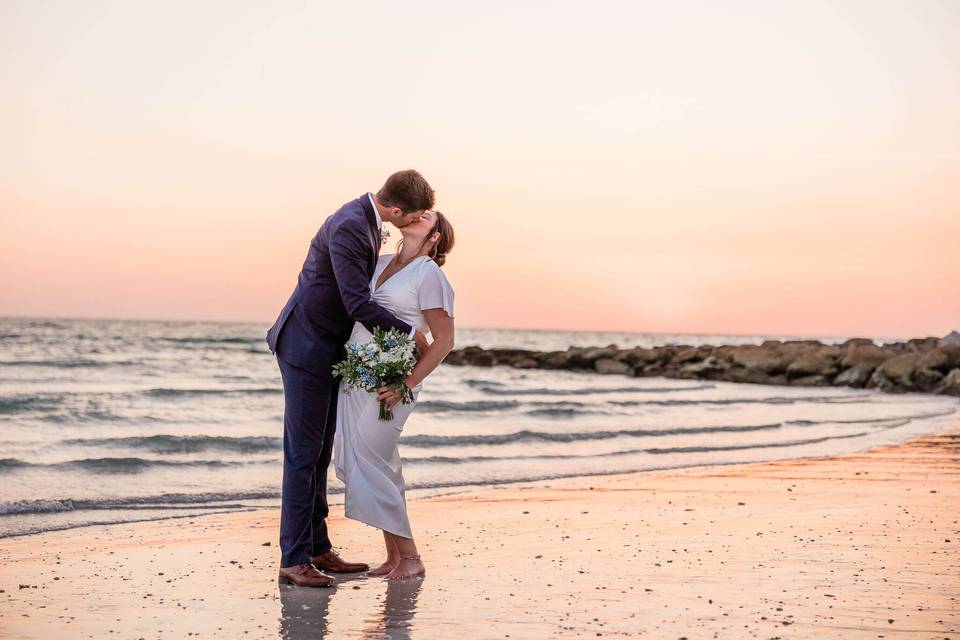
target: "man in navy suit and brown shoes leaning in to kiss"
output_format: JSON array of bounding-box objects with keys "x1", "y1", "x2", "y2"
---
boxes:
[{"x1": 267, "y1": 169, "x2": 434, "y2": 587}]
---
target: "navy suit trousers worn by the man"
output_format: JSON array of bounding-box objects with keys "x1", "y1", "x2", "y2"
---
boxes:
[{"x1": 277, "y1": 357, "x2": 340, "y2": 567}]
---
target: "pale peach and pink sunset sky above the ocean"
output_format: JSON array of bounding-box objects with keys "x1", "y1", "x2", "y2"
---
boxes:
[{"x1": 0, "y1": 0, "x2": 960, "y2": 337}]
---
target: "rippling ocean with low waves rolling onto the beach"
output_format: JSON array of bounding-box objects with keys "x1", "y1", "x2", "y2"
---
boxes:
[{"x1": 0, "y1": 318, "x2": 960, "y2": 537}]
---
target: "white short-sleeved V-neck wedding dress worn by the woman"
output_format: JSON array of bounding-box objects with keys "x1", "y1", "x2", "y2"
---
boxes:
[{"x1": 333, "y1": 255, "x2": 453, "y2": 538}]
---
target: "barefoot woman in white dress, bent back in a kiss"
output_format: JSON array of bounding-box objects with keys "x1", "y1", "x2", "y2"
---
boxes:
[{"x1": 333, "y1": 211, "x2": 454, "y2": 579}]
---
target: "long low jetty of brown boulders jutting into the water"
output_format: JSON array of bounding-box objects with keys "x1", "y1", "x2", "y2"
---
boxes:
[{"x1": 445, "y1": 331, "x2": 960, "y2": 396}]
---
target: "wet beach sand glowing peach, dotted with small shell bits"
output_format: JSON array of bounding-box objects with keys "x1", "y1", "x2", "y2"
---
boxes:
[{"x1": 0, "y1": 424, "x2": 960, "y2": 639}]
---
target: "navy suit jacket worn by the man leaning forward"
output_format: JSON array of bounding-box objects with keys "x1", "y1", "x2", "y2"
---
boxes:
[{"x1": 267, "y1": 194, "x2": 412, "y2": 377}]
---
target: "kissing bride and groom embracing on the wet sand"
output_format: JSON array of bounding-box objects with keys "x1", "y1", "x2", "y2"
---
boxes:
[{"x1": 267, "y1": 170, "x2": 454, "y2": 587}]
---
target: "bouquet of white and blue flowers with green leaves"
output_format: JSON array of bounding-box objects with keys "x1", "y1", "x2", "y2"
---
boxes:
[{"x1": 333, "y1": 327, "x2": 416, "y2": 420}]
